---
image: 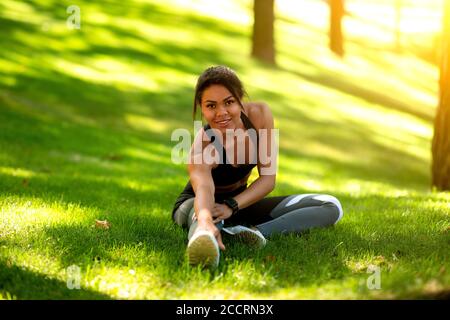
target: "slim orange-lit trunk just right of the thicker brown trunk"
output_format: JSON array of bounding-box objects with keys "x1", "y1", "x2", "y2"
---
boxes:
[{"x1": 328, "y1": 0, "x2": 345, "y2": 57}]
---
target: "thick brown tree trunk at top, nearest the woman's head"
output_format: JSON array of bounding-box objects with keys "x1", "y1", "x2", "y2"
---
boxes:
[{"x1": 252, "y1": 0, "x2": 275, "y2": 64}]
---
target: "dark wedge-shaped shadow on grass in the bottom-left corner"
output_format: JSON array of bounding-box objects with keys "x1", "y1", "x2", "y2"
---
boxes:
[{"x1": 0, "y1": 260, "x2": 111, "y2": 300}]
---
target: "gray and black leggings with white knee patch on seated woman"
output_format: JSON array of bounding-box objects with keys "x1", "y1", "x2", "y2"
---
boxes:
[{"x1": 174, "y1": 194, "x2": 343, "y2": 238}]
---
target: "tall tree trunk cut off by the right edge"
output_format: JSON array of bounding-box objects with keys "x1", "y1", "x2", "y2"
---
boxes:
[{"x1": 432, "y1": 0, "x2": 450, "y2": 191}]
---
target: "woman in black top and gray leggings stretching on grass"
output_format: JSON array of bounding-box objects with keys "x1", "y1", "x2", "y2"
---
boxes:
[{"x1": 172, "y1": 66, "x2": 343, "y2": 267}]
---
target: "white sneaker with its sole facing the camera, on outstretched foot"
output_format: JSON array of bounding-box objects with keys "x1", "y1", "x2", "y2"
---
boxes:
[{"x1": 186, "y1": 230, "x2": 220, "y2": 268}]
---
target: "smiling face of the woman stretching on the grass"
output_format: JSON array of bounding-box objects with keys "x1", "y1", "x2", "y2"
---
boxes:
[{"x1": 201, "y1": 84, "x2": 242, "y2": 132}]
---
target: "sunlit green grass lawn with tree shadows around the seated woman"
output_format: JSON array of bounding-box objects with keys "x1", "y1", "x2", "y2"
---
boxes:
[{"x1": 0, "y1": 0, "x2": 450, "y2": 299}]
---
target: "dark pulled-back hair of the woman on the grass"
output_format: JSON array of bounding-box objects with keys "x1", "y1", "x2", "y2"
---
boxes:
[{"x1": 192, "y1": 66, "x2": 247, "y2": 119}]
